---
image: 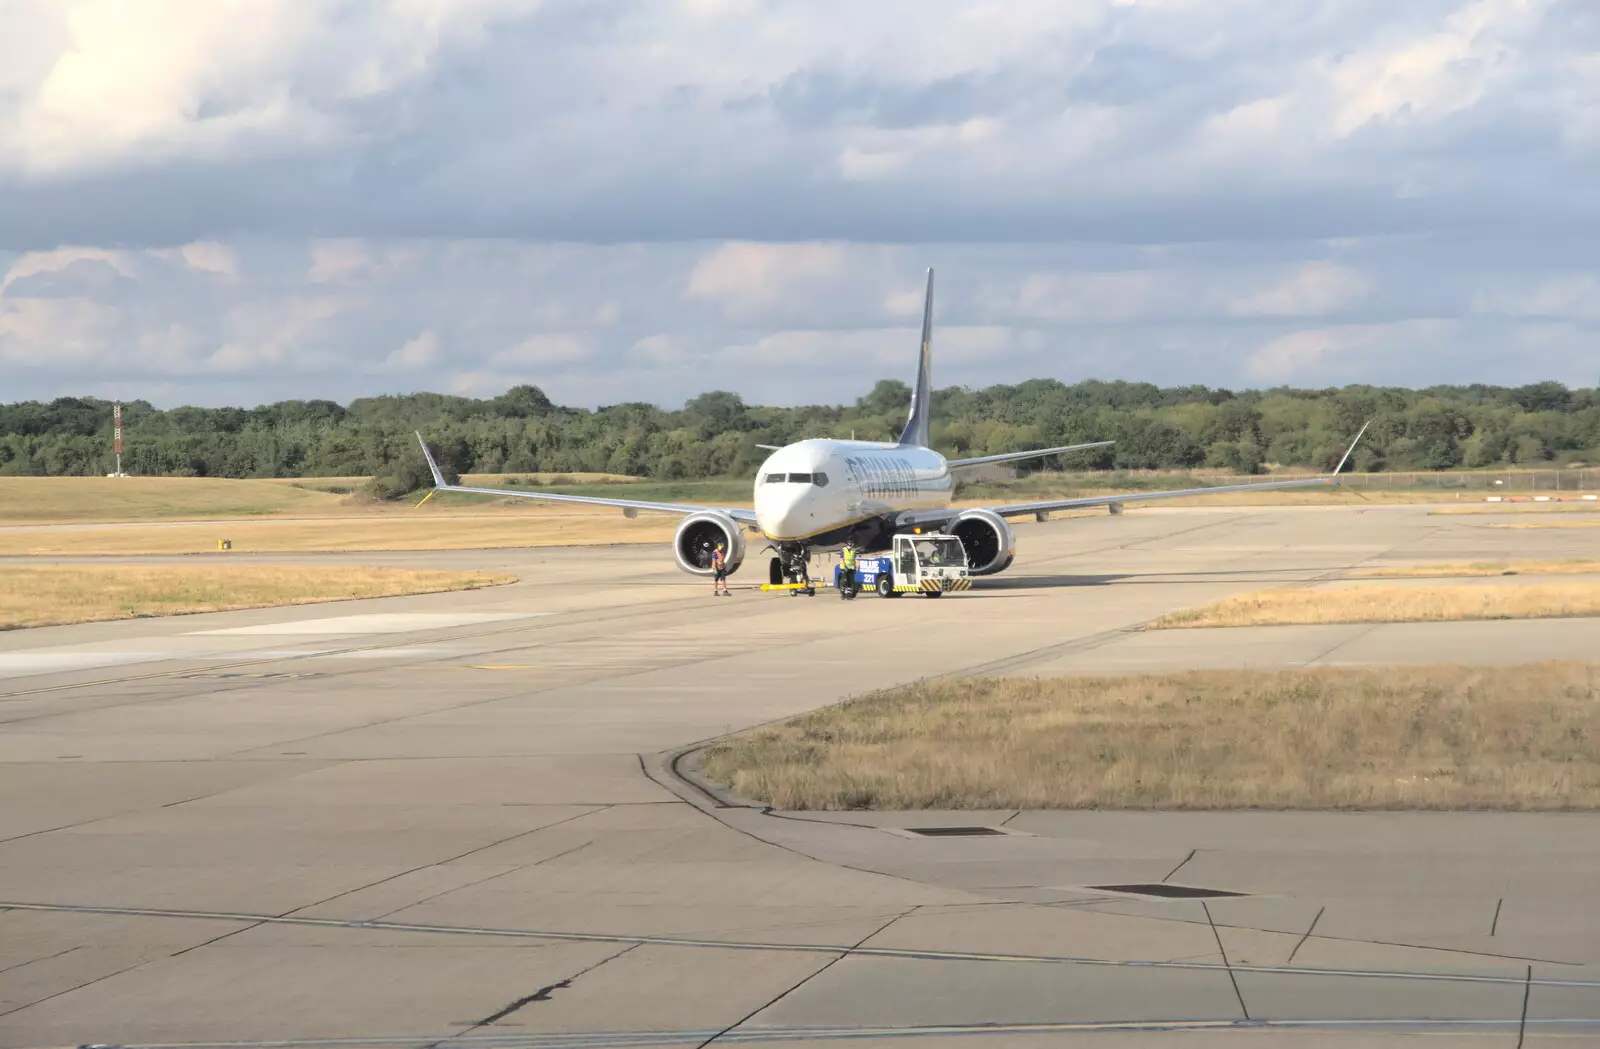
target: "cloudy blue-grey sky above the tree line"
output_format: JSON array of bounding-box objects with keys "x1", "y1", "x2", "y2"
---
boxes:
[{"x1": 0, "y1": 0, "x2": 1600, "y2": 408}]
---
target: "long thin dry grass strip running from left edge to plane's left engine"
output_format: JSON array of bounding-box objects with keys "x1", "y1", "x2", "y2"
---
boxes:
[{"x1": 0, "y1": 507, "x2": 678, "y2": 556}]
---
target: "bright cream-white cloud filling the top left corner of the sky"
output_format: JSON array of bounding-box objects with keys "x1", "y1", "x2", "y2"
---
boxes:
[{"x1": 0, "y1": 0, "x2": 539, "y2": 176}]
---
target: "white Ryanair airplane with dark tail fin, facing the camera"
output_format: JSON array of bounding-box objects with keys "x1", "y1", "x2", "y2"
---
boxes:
[{"x1": 418, "y1": 269, "x2": 1366, "y2": 584}]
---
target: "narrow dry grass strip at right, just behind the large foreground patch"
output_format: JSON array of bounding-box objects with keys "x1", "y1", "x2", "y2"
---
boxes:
[{"x1": 1150, "y1": 582, "x2": 1600, "y2": 630}]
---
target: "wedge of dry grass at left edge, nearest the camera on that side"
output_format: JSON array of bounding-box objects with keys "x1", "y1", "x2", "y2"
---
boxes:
[{"x1": 0, "y1": 564, "x2": 515, "y2": 630}]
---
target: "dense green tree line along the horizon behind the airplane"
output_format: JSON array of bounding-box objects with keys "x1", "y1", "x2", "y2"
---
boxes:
[{"x1": 0, "y1": 379, "x2": 1600, "y2": 480}]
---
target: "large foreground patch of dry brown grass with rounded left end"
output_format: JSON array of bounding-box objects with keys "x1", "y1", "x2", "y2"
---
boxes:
[{"x1": 702, "y1": 664, "x2": 1600, "y2": 809}]
